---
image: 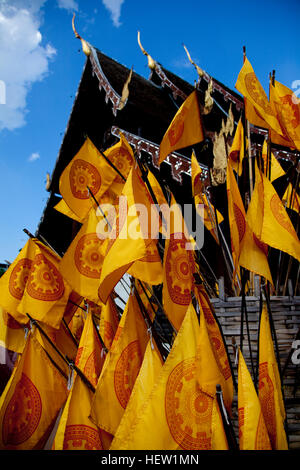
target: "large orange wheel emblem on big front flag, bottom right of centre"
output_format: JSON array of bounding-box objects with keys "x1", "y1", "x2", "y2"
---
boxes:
[{"x1": 165, "y1": 357, "x2": 213, "y2": 450}]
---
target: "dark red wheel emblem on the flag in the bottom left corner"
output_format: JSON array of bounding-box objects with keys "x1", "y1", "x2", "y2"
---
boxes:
[{"x1": 2, "y1": 373, "x2": 42, "y2": 446}]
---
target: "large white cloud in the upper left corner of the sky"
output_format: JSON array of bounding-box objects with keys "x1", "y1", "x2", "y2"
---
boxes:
[{"x1": 0, "y1": 0, "x2": 56, "y2": 131}]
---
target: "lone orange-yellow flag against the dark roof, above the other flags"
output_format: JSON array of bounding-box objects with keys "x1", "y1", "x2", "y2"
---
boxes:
[{"x1": 158, "y1": 90, "x2": 204, "y2": 164}]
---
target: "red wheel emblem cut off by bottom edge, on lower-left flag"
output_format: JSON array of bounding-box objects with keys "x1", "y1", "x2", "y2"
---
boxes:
[{"x1": 63, "y1": 424, "x2": 103, "y2": 450}]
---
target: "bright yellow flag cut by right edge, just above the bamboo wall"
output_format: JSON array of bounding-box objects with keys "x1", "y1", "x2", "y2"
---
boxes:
[{"x1": 251, "y1": 165, "x2": 300, "y2": 261}]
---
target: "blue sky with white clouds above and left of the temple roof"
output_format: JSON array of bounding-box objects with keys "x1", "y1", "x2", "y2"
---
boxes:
[{"x1": 0, "y1": 0, "x2": 300, "y2": 262}]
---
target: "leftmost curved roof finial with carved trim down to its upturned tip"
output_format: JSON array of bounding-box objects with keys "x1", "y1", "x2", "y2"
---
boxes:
[{"x1": 72, "y1": 13, "x2": 132, "y2": 116}]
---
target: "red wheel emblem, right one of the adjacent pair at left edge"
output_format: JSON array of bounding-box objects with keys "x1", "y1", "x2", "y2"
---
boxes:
[{"x1": 26, "y1": 253, "x2": 65, "y2": 302}]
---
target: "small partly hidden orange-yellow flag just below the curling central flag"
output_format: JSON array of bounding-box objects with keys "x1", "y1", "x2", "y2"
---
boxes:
[{"x1": 99, "y1": 296, "x2": 119, "y2": 349}]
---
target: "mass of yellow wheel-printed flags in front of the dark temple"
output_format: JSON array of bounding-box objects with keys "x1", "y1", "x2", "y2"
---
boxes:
[{"x1": 0, "y1": 82, "x2": 299, "y2": 450}]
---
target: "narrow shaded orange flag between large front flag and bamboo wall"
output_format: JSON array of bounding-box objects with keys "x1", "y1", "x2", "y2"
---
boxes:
[{"x1": 195, "y1": 284, "x2": 233, "y2": 413}]
